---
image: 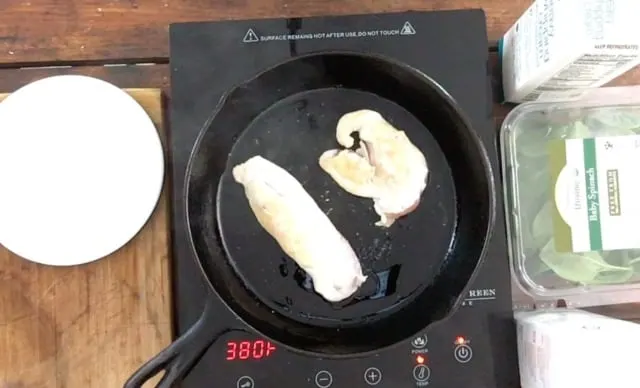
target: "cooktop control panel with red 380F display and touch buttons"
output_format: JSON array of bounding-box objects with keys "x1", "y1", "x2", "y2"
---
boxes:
[{"x1": 196, "y1": 302, "x2": 504, "y2": 388}]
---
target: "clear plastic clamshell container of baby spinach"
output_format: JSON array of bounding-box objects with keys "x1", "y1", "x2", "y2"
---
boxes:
[{"x1": 500, "y1": 87, "x2": 640, "y2": 310}]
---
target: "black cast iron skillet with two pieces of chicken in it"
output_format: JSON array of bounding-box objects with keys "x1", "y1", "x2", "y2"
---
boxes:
[{"x1": 125, "y1": 53, "x2": 496, "y2": 388}]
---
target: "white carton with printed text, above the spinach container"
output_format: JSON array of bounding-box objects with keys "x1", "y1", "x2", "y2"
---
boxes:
[{"x1": 498, "y1": 0, "x2": 640, "y2": 103}]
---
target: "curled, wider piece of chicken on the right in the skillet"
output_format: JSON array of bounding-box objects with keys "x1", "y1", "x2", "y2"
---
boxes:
[{"x1": 319, "y1": 109, "x2": 429, "y2": 227}]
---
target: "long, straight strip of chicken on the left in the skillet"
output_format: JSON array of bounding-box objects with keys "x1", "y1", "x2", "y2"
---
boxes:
[{"x1": 232, "y1": 156, "x2": 367, "y2": 302}]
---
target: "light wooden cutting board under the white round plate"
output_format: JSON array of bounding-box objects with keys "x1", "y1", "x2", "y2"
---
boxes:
[{"x1": 0, "y1": 89, "x2": 172, "y2": 388}]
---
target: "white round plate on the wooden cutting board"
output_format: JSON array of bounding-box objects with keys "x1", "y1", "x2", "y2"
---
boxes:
[{"x1": 0, "y1": 75, "x2": 164, "y2": 266}]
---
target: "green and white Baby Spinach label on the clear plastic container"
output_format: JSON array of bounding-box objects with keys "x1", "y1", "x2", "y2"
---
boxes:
[{"x1": 549, "y1": 135, "x2": 640, "y2": 252}]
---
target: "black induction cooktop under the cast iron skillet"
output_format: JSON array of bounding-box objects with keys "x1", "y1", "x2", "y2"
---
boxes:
[{"x1": 170, "y1": 10, "x2": 519, "y2": 388}]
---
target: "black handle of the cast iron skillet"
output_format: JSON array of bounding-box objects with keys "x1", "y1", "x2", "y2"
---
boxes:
[{"x1": 124, "y1": 302, "x2": 232, "y2": 388}]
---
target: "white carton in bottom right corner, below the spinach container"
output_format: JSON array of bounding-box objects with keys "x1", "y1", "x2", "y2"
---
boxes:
[{"x1": 515, "y1": 309, "x2": 640, "y2": 388}]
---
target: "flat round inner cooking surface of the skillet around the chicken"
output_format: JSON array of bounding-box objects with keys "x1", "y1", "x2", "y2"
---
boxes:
[{"x1": 218, "y1": 88, "x2": 457, "y2": 327}]
